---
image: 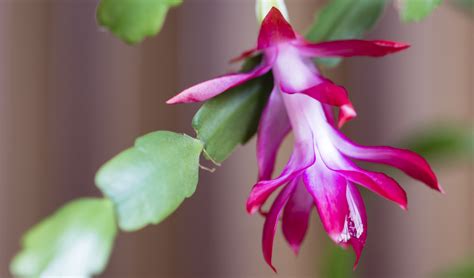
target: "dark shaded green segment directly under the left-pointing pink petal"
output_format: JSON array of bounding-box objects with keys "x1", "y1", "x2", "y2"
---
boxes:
[{"x1": 193, "y1": 70, "x2": 272, "y2": 163}]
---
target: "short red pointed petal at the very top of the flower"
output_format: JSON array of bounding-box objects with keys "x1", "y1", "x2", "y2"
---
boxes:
[{"x1": 257, "y1": 7, "x2": 296, "y2": 49}]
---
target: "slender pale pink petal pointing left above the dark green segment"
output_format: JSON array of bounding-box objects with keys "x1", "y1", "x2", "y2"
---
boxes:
[{"x1": 166, "y1": 59, "x2": 272, "y2": 104}]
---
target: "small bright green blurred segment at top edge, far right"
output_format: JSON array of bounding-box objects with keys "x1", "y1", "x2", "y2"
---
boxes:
[{"x1": 399, "y1": 0, "x2": 442, "y2": 22}]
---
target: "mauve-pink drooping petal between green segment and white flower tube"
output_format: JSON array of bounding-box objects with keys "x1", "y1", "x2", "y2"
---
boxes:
[{"x1": 257, "y1": 87, "x2": 291, "y2": 180}]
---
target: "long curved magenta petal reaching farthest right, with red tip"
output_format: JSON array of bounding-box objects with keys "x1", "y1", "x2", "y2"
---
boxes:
[{"x1": 332, "y1": 126, "x2": 442, "y2": 191}]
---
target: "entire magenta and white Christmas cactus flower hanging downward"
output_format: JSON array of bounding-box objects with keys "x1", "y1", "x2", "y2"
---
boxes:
[{"x1": 168, "y1": 8, "x2": 441, "y2": 269}]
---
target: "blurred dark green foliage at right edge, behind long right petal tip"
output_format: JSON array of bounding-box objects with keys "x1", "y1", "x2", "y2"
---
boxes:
[{"x1": 403, "y1": 125, "x2": 474, "y2": 160}]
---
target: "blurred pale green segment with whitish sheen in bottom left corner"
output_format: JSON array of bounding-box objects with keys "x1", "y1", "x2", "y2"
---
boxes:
[{"x1": 10, "y1": 198, "x2": 117, "y2": 277}]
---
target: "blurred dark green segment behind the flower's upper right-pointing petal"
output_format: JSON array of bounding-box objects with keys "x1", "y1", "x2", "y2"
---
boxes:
[{"x1": 306, "y1": 0, "x2": 388, "y2": 67}]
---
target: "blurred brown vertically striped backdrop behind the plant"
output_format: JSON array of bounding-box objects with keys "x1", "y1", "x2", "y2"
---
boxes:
[{"x1": 0, "y1": 0, "x2": 474, "y2": 278}]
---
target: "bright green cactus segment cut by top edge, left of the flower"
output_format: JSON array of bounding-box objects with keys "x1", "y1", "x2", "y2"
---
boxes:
[{"x1": 97, "y1": 0, "x2": 182, "y2": 44}]
